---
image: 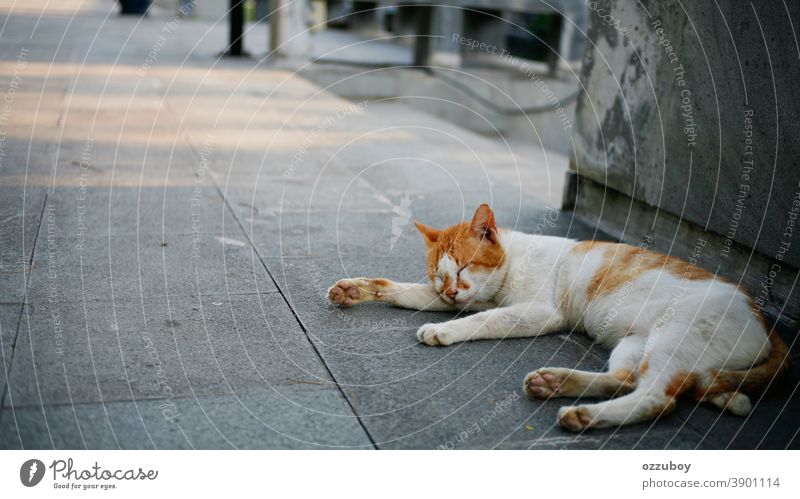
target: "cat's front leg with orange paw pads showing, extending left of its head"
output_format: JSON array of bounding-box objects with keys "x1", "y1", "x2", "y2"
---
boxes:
[{"x1": 328, "y1": 277, "x2": 456, "y2": 311}]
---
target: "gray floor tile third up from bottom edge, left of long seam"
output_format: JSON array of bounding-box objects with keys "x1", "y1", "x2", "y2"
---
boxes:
[{"x1": 28, "y1": 234, "x2": 277, "y2": 302}]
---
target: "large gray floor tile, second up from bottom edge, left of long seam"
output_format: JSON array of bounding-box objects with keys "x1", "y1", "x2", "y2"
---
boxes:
[{"x1": 6, "y1": 294, "x2": 333, "y2": 407}]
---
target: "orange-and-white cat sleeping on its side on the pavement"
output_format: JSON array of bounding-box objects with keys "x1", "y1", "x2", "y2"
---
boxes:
[{"x1": 328, "y1": 204, "x2": 789, "y2": 431}]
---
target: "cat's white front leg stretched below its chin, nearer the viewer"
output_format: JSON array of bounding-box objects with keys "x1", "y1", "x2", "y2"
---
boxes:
[{"x1": 417, "y1": 303, "x2": 564, "y2": 346}]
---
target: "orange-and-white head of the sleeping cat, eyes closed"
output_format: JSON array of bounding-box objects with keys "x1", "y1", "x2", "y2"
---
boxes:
[{"x1": 416, "y1": 204, "x2": 505, "y2": 306}]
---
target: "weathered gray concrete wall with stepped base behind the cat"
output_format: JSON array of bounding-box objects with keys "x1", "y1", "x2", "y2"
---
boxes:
[{"x1": 565, "y1": 0, "x2": 800, "y2": 317}]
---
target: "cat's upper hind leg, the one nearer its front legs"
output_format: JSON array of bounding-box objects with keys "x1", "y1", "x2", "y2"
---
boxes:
[{"x1": 523, "y1": 336, "x2": 644, "y2": 399}]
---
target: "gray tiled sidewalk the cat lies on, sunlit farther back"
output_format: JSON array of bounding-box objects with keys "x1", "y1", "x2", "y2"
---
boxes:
[{"x1": 0, "y1": 0, "x2": 800, "y2": 449}]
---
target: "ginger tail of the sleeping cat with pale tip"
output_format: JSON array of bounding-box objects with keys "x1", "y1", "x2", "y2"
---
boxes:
[{"x1": 695, "y1": 329, "x2": 791, "y2": 415}]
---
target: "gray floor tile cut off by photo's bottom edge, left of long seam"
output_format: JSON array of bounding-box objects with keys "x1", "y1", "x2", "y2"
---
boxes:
[{"x1": 0, "y1": 385, "x2": 372, "y2": 449}]
